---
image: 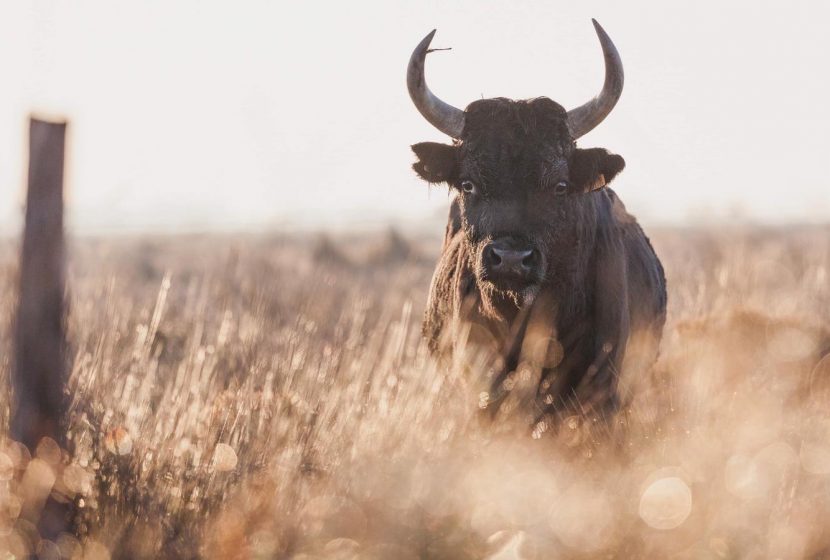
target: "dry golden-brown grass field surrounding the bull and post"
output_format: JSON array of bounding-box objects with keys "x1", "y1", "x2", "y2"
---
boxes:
[{"x1": 0, "y1": 227, "x2": 830, "y2": 560}]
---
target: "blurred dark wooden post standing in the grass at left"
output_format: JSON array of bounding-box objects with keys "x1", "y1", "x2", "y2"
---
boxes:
[{"x1": 10, "y1": 119, "x2": 71, "y2": 539}]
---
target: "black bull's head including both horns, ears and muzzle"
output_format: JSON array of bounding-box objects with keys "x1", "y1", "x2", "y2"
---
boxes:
[{"x1": 407, "y1": 21, "x2": 625, "y2": 299}]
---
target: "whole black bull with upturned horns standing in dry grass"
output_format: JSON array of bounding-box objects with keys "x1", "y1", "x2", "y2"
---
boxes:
[{"x1": 408, "y1": 22, "x2": 666, "y2": 422}]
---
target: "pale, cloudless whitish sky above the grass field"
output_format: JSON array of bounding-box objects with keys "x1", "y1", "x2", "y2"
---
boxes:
[{"x1": 0, "y1": 0, "x2": 830, "y2": 233}]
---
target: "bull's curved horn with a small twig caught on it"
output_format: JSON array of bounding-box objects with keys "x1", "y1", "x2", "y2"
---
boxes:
[{"x1": 406, "y1": 29, "x2": 464, "y2": 138}]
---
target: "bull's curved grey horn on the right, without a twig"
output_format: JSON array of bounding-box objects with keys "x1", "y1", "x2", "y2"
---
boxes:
[{"x1": 568, "y1": 19, "x2": 624, "y2": 140}]
